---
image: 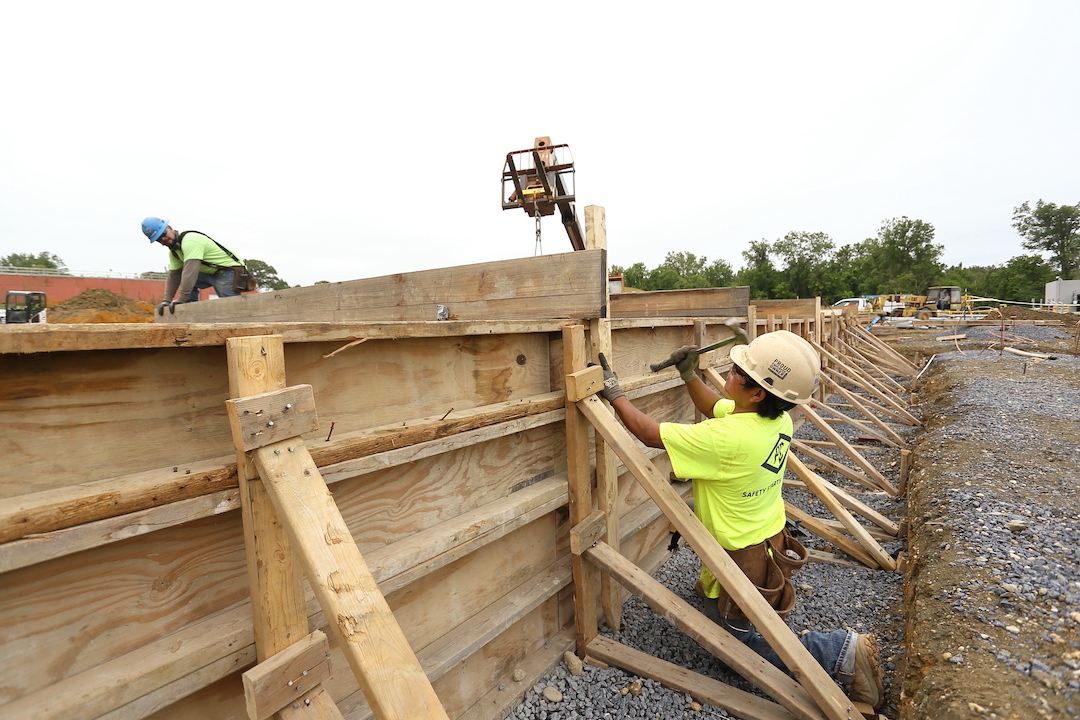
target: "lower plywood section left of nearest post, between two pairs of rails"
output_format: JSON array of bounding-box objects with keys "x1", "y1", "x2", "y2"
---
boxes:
[{"x1": 0, "y1": 513, "x2": 247, "y2": 703}]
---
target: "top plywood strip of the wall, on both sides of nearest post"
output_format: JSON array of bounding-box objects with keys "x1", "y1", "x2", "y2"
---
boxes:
[{"x1": 0, "y1": 334, "x2": 550, "y2": 498}]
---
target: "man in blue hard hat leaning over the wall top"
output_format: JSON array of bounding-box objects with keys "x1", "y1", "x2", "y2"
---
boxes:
[{"x1": 143, "y1": 217, "x2": 255, "y2": 315}]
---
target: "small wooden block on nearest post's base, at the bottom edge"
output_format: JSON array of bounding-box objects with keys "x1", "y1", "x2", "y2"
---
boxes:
[{"x1": 243, "y1": 630, "x2": 330, "y2": 720}]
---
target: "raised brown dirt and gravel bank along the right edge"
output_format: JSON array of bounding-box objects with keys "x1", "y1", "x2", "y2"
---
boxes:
[{"x1": 881, "y1": 308, "x2": 1080, "y2": 720}]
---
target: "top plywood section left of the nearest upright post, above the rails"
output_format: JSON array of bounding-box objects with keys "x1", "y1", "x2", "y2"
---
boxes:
[{"x1": 0, "y1": 348, "x2": 232, "y2": 498}]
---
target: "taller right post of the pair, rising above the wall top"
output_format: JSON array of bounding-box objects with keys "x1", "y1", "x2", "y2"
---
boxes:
[{"x1": 585, "y1": 205, "x2": 623, "y2": 630}]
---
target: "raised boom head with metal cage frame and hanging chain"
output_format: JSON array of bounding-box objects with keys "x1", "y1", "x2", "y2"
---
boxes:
[{"x1": 502, "y1": 137, "x2": 585, "y2": 250}]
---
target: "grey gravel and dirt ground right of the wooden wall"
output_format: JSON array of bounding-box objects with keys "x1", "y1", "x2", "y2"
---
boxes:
[{"x1": 509, "y1": 326, "x2": 1080, "y2": 720}]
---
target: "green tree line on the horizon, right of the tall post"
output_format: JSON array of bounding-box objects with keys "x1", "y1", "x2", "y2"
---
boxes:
[{"x1": 611, "y1": 200, "x2": 1080, "y2": 302}]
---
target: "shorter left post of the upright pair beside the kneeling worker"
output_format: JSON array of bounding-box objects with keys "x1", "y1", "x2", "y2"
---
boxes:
[{"x1": 563, "y1": 325, "x2": 598, "y2": 657}]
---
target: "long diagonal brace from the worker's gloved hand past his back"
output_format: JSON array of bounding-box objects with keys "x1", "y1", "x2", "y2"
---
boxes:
[{"x1": 577, "y1": 396, "x2": 850, "y2": 720}]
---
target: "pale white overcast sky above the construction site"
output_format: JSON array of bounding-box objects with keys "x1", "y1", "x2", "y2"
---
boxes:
[{"x1": 0, "y1": 0, "x2": 1080, "y2": 285}]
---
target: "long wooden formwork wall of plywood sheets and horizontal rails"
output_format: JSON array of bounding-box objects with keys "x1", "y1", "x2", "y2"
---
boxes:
[{"x1": 0, "y1": 236, "x2": 829, "y2": 720}]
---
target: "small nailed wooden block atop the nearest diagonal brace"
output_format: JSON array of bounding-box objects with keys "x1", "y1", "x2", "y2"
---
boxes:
[{"x1": 226, "y1": 385, "x2": 319, "y2": 452}]
